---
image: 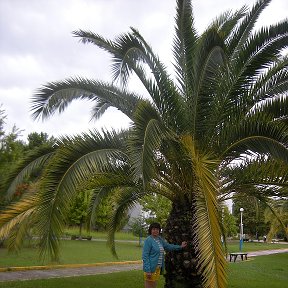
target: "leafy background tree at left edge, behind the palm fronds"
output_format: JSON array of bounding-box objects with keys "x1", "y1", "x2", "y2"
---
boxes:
[{"x1": 0, "y1": 106, "x2": 56, "y2": 206}]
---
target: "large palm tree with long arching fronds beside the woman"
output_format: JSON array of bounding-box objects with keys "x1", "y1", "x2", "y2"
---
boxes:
[{"x1": 0, "y1": 0, "x2": 288, "y2": 288}]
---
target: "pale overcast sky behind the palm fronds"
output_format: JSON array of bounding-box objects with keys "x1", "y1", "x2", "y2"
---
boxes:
[{"x1": 0, "y1": 0, "x2": 288, "y2": 140}]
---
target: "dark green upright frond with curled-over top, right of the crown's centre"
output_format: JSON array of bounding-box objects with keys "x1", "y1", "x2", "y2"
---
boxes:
[{"x1": 192, "y1": 27, "x2": 227, "y2": 139}]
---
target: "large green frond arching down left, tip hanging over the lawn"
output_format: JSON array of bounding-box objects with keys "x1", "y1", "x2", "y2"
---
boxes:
[{"x1": 32, "y1": 131, "x2": 129, "y2": 258}]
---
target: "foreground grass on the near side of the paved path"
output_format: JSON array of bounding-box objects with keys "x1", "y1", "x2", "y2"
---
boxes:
[{"x1": 0, "y1": 253, "x2": 288, "y2": 288}]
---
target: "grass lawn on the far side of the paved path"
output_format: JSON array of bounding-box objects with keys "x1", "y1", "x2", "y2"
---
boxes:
[{"x1": 0, "y1": 236, "x2": 288, "y2": 267}]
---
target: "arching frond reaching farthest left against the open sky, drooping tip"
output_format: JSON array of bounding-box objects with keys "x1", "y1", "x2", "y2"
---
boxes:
[{"x1": 31, "y1": 77, "x2": 141, "y2": 119}]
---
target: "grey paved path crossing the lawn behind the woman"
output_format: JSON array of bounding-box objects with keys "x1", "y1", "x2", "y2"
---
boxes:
[{"x1": 0, "y1": 248, "x2": 288, "y2": 282}]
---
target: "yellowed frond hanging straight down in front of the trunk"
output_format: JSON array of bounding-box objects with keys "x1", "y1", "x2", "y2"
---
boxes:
[{"x1": 184, "y1": 144, "x2": 227, "y2": 287}]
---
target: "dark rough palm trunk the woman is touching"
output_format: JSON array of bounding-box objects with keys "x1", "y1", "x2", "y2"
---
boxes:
[{"x1": 164, "y1": 201, "x2": 202, "y2": 288}]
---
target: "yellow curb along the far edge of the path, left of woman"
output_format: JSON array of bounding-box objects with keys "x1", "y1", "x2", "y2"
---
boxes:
[{"x1": 0, "y1": 260, "x2": 142, "y2": 272}]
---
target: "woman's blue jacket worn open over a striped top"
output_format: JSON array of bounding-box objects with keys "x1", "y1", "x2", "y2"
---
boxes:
[{"x1": 142, "y1": 235, "x2": 182, "y2": 273}]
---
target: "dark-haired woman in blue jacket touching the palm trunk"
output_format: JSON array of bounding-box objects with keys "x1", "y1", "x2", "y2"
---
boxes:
[{"x1": 142, "y1": 223, "x2": 187, "y2": 288}]
